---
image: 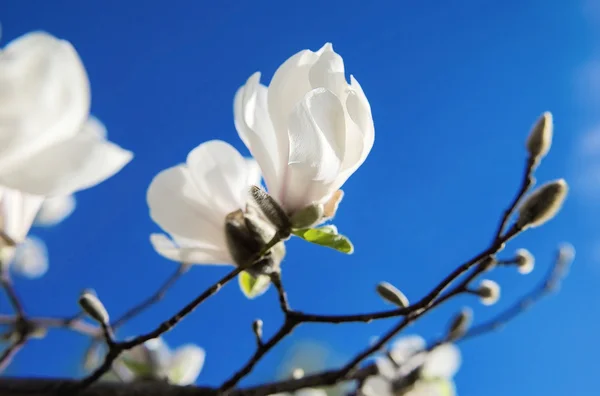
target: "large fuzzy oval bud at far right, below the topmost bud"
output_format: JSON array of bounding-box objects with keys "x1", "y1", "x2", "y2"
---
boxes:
[{"x1": 517, "y1": 179, "x2": 569, "y2": 229}]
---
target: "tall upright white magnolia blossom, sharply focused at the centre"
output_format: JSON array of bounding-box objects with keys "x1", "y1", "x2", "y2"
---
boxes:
[{"x1": 234, "y1": 43, "x2": 375, "y2": 220}]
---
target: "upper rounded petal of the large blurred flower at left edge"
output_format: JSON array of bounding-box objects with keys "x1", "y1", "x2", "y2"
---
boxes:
[{"x1": 0, "y1": 32, "x2": 90, "y2": 170}]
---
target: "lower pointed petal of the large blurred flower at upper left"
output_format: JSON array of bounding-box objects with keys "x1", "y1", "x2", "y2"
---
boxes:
[{"x1": 0, "y1": 119, "x2": 133, "y2": 195}]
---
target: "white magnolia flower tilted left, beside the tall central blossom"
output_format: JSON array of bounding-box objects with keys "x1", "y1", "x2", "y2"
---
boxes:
[{"x1": 147, "y1": 140, "x2": 275, "y2": 264}]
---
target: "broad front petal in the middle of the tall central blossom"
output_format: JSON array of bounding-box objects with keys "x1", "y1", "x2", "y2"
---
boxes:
[{"x1": 281, "y1": 88, "x2": 346, "y2": 213}]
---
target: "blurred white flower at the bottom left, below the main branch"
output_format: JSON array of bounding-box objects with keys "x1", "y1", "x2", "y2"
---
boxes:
[{"x1": 118, "y1": 338, "x2": 205, "y2": 386}]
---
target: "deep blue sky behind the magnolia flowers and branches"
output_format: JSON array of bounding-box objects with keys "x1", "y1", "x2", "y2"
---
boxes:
[{"x1": 0, "y1": 0, "x2": 600, "y2": 396}]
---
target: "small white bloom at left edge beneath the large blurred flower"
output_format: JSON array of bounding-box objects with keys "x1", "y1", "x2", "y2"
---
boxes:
[{"x1": 0, "y1": 187, "x2": 44, "y2": 265}]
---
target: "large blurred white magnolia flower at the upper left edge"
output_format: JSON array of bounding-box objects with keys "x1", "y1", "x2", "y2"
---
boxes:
[{"x1": 0, "y1": 32, "x2": 133, "y2": 196}]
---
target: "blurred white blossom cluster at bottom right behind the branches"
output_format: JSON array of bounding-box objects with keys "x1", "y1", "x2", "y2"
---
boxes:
[{"x1": 361, "y1": 336, "x2": 460, "y2": 396}]
